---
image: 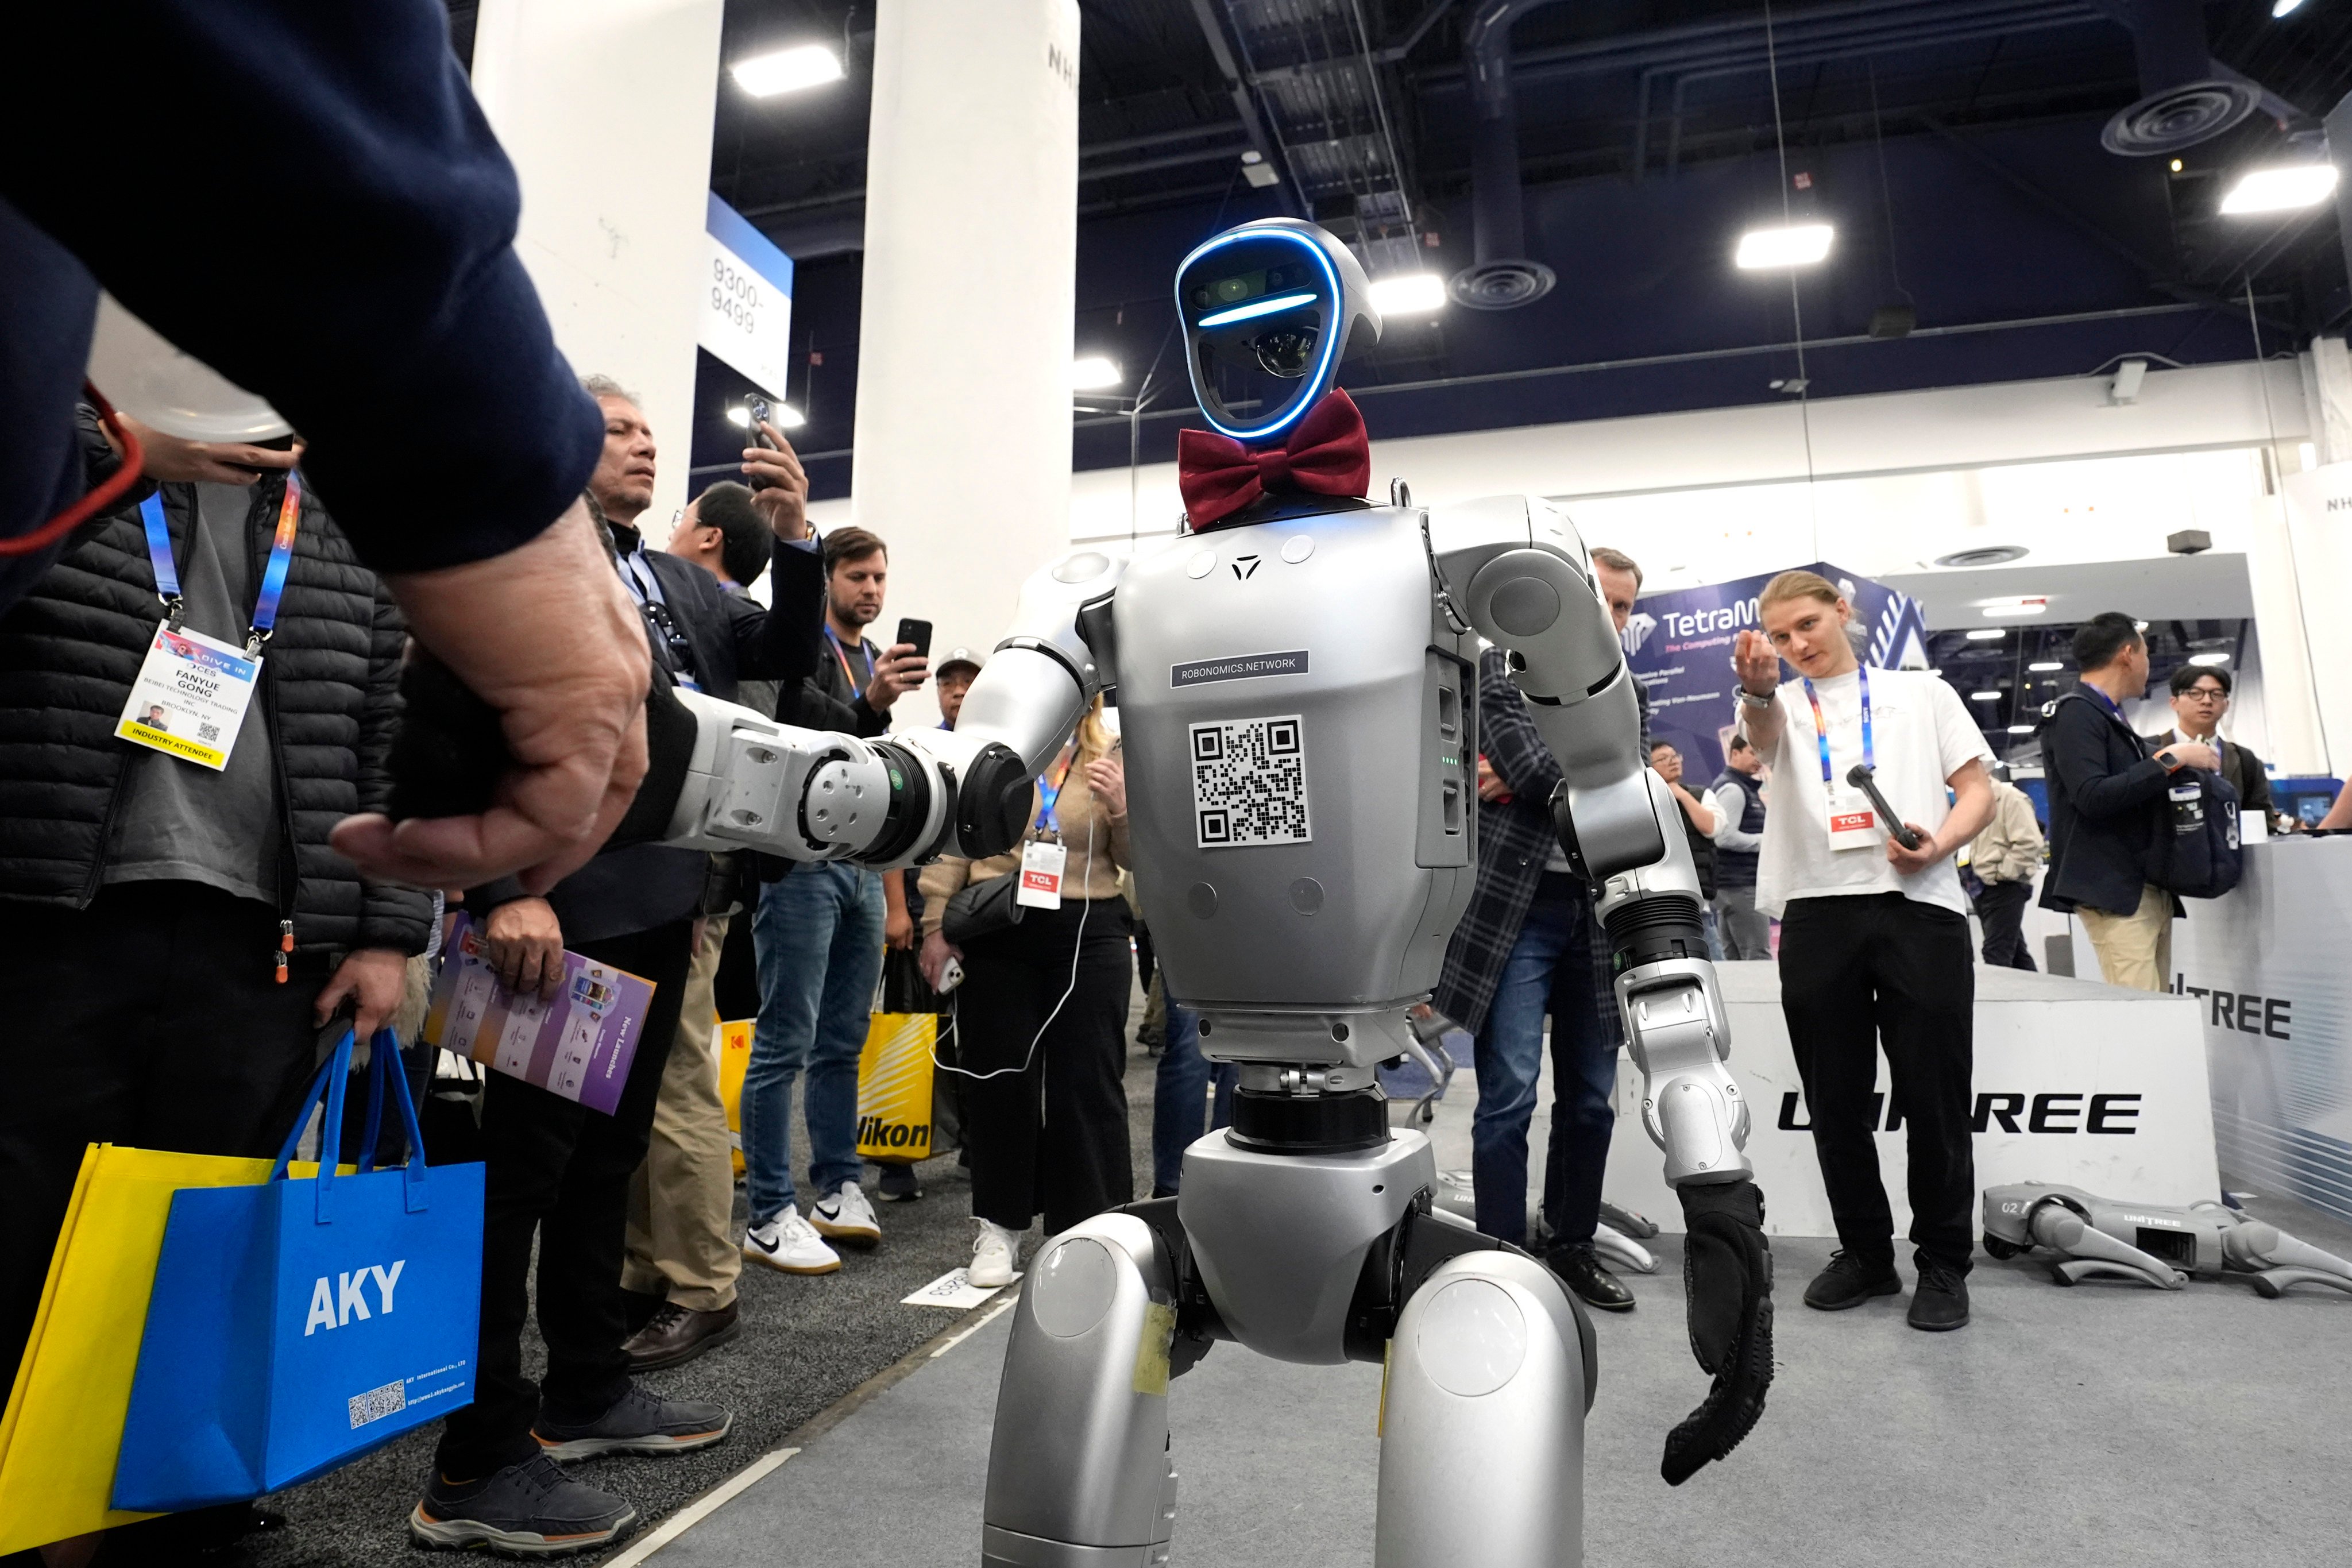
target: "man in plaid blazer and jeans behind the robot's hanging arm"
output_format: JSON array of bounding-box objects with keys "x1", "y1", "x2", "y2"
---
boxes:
[{"x1": 1430, "y1": 550, "x2": 1649, "y2": 1312}]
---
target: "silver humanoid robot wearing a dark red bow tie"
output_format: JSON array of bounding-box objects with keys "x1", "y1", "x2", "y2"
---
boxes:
[{"x1": 569, "y1": 219, "x2": 1771, "y2": 1568}]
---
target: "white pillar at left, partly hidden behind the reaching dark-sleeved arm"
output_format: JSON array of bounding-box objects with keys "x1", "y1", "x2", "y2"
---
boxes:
[{"x1": 473, "y1": 0, "x2": 724, "y2": 526}]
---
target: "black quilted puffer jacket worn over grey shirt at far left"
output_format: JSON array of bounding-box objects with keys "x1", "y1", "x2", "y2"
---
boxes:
[{"x1": 0, "y1": 465, "x2": 432, "y2": 957}]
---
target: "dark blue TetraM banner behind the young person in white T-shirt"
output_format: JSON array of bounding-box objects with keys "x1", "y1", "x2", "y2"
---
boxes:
[{"x1": 1623, "y1": 562, "x2": 1929, "y2": 785}]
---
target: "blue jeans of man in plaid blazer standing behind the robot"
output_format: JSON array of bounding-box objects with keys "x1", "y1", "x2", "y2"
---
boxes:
[{"x1": 1470, "y1": 872, "x2": 1618, "y2": 1246}]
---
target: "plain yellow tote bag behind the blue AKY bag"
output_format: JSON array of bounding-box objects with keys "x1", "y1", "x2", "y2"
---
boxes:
[{"x1": 0, "y1": 1142, "x2": 277, "y2": 1557}]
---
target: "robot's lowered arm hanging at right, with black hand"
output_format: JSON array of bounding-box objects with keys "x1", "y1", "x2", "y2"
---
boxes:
[{"x1": 1428, "y1": 496, "x2": 1771, "y2": 1486}]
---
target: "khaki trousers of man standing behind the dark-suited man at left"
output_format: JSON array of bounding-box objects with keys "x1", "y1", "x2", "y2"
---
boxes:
[{"x1": 621, "y1": 914, "x2": 743, "y2": 1312}]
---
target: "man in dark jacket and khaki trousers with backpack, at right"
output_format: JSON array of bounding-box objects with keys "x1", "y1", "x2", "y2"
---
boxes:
[{"x1": 2041, "y1": 609, "x2": 2220, "y2": 992}]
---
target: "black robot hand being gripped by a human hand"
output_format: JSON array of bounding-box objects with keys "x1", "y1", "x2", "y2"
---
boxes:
[{"x1": 388, "y1": 651, "x2": 694, "y2": 851}]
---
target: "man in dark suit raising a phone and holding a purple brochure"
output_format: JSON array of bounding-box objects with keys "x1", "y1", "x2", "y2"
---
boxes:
[{"x1": 423, "y1": 376, "x2": 823, "y2": 1551}]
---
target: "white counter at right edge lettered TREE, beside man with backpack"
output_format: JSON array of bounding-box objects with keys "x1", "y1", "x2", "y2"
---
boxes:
[{"x1": 2164, "y1": 839, "x2": 2352, "y2": 1220}]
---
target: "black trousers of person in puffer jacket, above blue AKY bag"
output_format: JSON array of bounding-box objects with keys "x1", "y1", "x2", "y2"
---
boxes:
[{"x1": 0, "y1": 882, "x2": 331, "y2": 1377}]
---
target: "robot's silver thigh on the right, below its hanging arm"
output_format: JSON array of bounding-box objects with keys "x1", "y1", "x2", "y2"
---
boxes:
[{"x1": 1373, "y1": 1250, "x2": 1592, "y2": 1568}]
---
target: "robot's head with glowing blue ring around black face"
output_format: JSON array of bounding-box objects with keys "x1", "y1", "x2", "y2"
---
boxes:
[{"x1": 1176, "y1": 219, "x2": 1381, "y2": 442}]
